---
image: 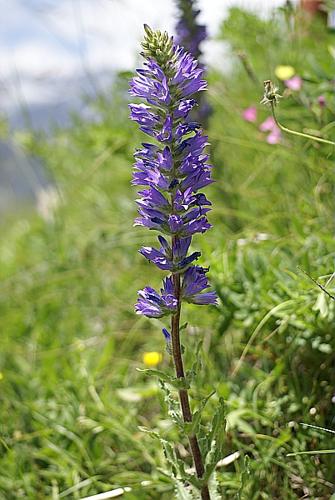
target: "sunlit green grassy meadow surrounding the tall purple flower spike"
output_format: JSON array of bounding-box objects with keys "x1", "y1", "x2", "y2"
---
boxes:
[{"x1": 0, "y1": 1, "x2": 335, "y2": 500}]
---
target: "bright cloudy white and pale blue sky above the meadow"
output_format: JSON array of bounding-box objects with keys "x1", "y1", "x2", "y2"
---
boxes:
[{"x1": 0, "y1": 0, "x2": 292, "y2": 127}]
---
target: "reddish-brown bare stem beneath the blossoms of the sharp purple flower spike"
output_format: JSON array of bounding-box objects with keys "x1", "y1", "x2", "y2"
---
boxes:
[{"x1": 171, "y1": 258, "x2": 210, "y2": 500}]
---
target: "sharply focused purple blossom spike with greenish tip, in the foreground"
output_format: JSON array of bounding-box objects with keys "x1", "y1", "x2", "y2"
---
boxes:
[{"x1": 130, "y1": 26, "x2": 217, "y2": 320}]
